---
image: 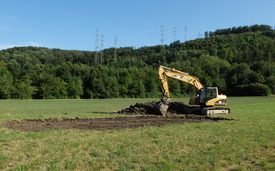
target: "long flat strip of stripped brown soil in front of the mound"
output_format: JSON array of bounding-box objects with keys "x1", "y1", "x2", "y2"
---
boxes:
[{"x1": 0, "y1": 115, "x2": 233, "y2": 132}]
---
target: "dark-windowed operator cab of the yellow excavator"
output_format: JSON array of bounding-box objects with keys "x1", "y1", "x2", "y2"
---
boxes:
[{"x1": 200, "y1": 87, "x2": 218, "y2": 106}]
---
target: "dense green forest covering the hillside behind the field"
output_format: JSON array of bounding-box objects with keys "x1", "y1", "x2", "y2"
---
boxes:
[{"x1": 0, "y1": 25, "x2": 275, "y2": 99}]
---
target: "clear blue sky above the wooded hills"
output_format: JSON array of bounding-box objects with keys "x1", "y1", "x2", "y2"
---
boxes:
[{"x1": 0, "y1": 0, "x2": 275, "y2": 51}]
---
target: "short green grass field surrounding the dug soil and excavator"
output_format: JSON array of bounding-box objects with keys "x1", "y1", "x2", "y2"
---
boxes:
[{"x1": 0, "y1": 97, "x2": 275, "y2": 170}]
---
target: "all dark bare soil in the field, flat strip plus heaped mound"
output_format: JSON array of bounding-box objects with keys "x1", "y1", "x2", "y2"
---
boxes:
[{"x1": 0, "y1": 102, "x2": 234, "y2": 132}]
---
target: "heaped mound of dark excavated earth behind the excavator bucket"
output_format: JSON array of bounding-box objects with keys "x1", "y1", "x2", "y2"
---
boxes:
[{"x1": 117, "y1": 102, "x2": 194, "y2": 116}]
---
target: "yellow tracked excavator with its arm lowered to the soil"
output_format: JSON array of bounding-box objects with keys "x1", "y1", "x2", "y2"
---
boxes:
[{"x1": 153, "y1": 65, "x2": 230, "y2": 116}]
